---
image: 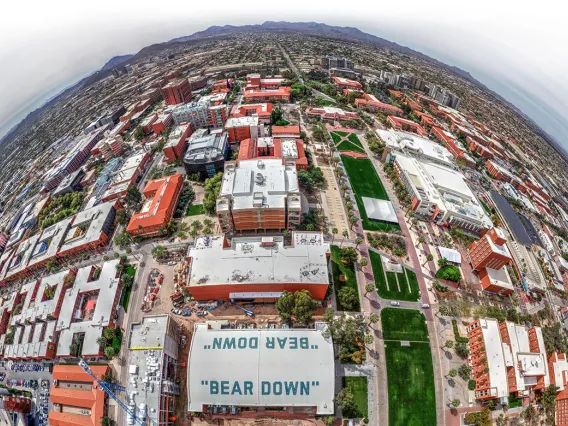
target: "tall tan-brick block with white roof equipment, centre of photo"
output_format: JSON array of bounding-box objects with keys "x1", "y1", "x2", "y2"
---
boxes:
[{"x1": 217, "y1": 159, "x2": 302, "y2": 233}]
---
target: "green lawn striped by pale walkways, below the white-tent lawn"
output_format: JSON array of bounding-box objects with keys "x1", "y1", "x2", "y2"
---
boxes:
[{"x1": 369, "y1": 250, "x2": 420, "y2": 302}]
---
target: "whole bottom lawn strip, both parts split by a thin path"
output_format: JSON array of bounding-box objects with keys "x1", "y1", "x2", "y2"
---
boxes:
[{"x1": 381, "y1": 308, "x2": 436, "y2": 426}]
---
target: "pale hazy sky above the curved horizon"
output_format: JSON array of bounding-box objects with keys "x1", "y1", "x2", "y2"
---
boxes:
[{"x1": 0, "y1": 0, "x2": 568, "y2": 148}]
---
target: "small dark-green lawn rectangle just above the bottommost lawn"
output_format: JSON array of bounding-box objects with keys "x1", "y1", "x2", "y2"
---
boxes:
[{"x1": 381, "y1": 308, "x2": 429, "y2": 342}]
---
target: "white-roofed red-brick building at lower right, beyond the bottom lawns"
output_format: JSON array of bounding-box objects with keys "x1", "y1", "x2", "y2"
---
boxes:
[{"x1": 467, "y1": 318, "x2": 551, "y2": 403}]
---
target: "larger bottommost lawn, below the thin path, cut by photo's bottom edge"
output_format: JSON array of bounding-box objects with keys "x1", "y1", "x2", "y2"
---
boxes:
[{"x1": 383, "y1": 342, "x2": 436, "y2": 426}]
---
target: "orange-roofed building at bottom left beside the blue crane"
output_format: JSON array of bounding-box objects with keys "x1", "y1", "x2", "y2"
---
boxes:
[{"x1": 49, "y1": 365, "x2": 109, "y2": 426}]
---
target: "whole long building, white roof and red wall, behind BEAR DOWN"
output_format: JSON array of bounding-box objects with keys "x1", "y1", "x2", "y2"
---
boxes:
[{"x1": 186, "y1": 232, "x2": 329, "y2": 302}]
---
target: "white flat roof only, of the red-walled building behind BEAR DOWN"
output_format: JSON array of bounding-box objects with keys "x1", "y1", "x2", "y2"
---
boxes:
[{"x1": 188, "y1": 232, "x2": 329, "y2": 287}]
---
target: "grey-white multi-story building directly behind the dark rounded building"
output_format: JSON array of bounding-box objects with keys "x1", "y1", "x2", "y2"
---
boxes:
[{"x1": 172, "y1": 98, "x2": 228, "y2": 129}]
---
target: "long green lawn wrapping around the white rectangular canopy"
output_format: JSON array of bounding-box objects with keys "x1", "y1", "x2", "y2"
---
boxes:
[{"x1": 341, "y1": 155, "x2": 400, "y2": 232}]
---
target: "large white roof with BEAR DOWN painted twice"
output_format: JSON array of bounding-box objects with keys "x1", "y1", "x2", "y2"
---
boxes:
[{"x1": 188, "y1": 323, "x2": 335, "y2": 414}]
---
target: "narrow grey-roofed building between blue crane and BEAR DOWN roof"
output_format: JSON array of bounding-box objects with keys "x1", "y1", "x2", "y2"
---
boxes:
[{"x1": 124, "y1": 315, "x2": 181, "y2": 426}]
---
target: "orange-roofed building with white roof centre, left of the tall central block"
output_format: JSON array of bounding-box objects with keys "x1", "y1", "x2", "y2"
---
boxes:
[{"x1": 126, "y1": 174, "x2": 183, "y2": 237}]
